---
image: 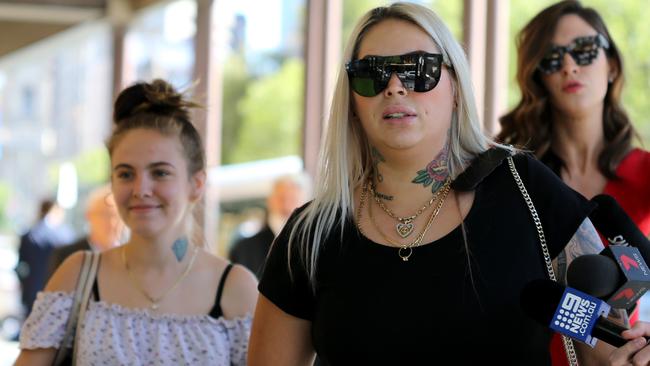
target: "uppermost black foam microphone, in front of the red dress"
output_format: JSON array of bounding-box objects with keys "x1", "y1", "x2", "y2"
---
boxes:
[{"x1": 589, "y1": 194, "x2": 650, "y2": 261}]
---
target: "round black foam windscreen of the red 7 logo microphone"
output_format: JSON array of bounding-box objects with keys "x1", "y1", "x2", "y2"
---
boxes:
[{"x1": 567, "y1": 254, "x2": 621, "y2": 298}]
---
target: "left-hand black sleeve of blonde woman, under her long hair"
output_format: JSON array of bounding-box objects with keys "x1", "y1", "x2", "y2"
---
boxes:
[{"x1": 258, "y1": 210, "x2": 314, "y2": 320}]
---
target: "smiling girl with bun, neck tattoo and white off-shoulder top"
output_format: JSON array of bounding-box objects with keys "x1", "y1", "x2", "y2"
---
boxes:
[{"x1": 12, "y1": 80, "x2": 257, "y2": 366}]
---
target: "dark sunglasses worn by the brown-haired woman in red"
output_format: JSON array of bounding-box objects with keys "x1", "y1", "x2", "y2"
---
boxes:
[{"x1": 537, "y1": 33, "x2": 609, "y2": 75}]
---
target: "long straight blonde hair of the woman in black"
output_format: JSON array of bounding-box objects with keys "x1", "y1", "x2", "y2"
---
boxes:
[{"x1": 287, "y1": 3, "x2": 492, "y2": 285}]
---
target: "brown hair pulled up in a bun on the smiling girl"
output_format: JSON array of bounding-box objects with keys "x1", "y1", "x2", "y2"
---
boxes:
[{"x1": 106, "y1": 79, "x2": 205, "y2": 176}]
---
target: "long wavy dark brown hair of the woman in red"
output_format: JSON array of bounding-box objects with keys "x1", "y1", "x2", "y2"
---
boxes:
[{"x1": 497, "y1": 0, "x2": 636, "y2": 179}]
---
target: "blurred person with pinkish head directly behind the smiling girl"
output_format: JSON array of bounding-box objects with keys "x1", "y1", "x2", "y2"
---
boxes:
[{"x1": 48, "y1": 185, "x2": 124, "y2": 278}]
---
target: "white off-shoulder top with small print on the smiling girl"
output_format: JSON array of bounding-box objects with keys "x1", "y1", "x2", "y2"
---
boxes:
[{"x1": 20, "y1": 292, "x2": 252, "y2": 366}]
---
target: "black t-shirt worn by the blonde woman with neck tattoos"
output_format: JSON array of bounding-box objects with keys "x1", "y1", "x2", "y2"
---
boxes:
[{"x1": 259, "y1": 155, "x2": 592, "y2": 365}]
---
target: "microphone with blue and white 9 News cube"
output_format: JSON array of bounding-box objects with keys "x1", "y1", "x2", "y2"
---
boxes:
[{"x1": 521, "y1": 279, "x2": 628, "y2": 347}]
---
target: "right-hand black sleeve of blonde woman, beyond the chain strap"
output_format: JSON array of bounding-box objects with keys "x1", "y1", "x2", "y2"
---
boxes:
[{"x1": 514, "y1": 154, "x2": 596, "y2": 258}]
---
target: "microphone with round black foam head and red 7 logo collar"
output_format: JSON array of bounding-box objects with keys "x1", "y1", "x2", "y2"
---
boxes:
[{"x1": 567, "y1": 250, "x2": 650, "y2": 309}]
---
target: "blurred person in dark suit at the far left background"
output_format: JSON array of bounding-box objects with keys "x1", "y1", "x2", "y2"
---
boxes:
[{"x1": 16, "y1": 199, "x2": 74, "y2": 316}]
